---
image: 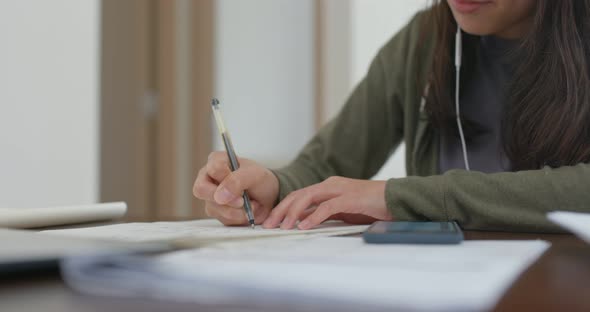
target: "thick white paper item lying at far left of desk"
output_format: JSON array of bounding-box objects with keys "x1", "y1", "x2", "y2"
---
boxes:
[{"x1": 0, "y1": 202, "x2": 127, "y2": 229}]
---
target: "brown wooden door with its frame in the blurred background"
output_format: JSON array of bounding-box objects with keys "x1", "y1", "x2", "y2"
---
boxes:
[{"x1": 100, "y1": 0, "x2": 214, "y2": 221}]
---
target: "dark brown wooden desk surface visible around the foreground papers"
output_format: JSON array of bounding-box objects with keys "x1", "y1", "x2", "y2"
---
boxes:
[{"x1": 0, "y1": 231, "x2": 590, "y2": 312}]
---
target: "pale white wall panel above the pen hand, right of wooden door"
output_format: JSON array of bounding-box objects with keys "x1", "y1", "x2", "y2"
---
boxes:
[{"x1": 214, "y1": 0, "x2": 314, "y2": 166}]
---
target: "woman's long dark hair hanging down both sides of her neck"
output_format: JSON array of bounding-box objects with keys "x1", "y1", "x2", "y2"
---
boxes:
[{"x1": 425, "y1": 0, "x2": 590, "y2": 170}]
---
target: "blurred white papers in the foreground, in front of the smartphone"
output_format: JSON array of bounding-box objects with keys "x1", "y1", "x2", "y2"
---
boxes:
[{"x1": 62, "y1": 237, "x2": 549, "y2": 311}]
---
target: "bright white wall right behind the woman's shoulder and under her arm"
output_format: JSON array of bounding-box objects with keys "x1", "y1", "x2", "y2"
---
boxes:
[{"x1": 349, "y1": 0, "x2": 428, "y2": 180}]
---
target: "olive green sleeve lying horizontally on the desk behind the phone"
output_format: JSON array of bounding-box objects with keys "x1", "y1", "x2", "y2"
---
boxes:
[{"x1": 385, "y1": 164, "x2": 590, "y2": 232}]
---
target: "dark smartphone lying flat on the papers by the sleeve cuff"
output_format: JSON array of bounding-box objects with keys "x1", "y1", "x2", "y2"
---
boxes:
[{"x1": 363, "y1": 221, "x2": 463, "y2": 244}]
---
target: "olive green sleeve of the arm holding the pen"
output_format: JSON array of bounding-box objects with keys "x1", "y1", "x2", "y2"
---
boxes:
[{"x1": 273, "y1": 13, "x2": 419, "y2": 201}]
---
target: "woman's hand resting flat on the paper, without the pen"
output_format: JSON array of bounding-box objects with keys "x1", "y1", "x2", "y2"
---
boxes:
[{"x1": 262, "y1": 177, "x2": 393, "y2": 230}]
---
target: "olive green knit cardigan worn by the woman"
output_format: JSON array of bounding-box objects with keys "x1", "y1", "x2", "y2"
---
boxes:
[{"x1": 274, "y1": 13, "x2": 590, "y2": 232}]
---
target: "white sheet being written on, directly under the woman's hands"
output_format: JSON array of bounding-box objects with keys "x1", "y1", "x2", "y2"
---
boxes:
[{"x1": 43, "y1": 219, "x2": 368, "y2": 246}]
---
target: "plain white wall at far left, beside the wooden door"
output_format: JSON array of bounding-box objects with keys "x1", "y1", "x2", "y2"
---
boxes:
[{"x1": 0, "y1": 0, "x2": 99, "y2": 207}]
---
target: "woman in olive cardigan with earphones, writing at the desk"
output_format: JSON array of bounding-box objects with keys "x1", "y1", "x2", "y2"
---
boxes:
[{"x1": 194, "y1": 0, "x2": 590, "y2": 231}]
